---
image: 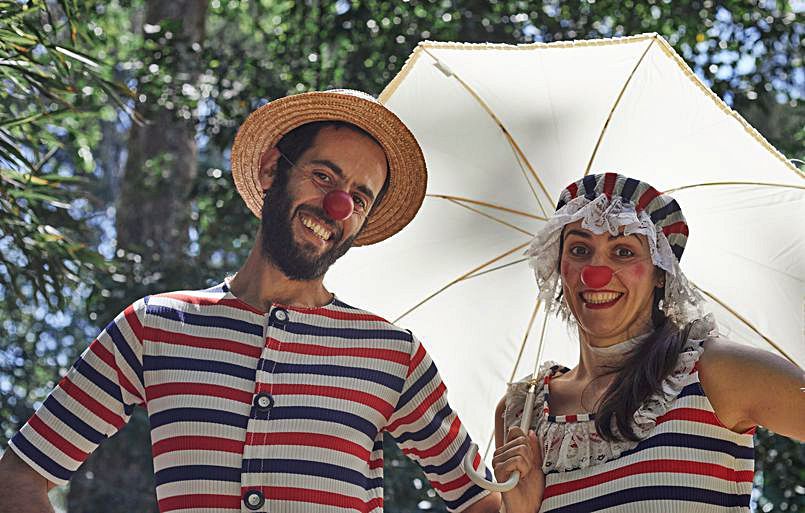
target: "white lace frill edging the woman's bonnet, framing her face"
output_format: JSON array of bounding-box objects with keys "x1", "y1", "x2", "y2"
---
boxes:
[{"x1": 525, "y1": 194, "x2": 703, "y2": 326}]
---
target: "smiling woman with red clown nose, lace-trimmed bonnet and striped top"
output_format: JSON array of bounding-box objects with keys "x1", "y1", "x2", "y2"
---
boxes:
[{"x1": 492, "y1": 173, "x2": 805, "y2": 513}]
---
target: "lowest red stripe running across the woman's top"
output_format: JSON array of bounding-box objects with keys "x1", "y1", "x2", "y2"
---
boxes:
[{"x1": 543, "y1": 460, "x2": 754, "y2": 500}]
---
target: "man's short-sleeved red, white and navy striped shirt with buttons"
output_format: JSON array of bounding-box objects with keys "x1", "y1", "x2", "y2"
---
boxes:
[{"x1": 10, "y1": 284, "x2": 486, "y2": 513}]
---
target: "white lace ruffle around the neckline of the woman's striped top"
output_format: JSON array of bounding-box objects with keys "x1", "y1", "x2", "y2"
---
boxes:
[{"x1": 503, "y1": 315, "x2": 717, "y2": 473}]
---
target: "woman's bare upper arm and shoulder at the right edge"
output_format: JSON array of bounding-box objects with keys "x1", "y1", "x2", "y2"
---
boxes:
[{"x1": 699, "y1": 339, "x2": 805, "y2": 440}]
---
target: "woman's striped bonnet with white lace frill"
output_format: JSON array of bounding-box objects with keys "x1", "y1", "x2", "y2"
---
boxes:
[{"x1": 526, "y1": 173, "x2": 703, "y2": 326}]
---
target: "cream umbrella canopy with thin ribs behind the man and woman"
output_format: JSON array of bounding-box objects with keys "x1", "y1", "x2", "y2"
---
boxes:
[{"x1": 327, "y1": 34, "x2": 805, "y2": 458}]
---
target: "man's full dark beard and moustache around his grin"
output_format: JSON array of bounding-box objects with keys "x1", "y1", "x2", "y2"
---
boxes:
[{"x1": 260, "y1": 176, "x2": 357, "y2": 281}]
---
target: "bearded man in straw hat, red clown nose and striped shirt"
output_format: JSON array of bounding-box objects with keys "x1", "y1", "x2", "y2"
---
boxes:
[{"x1": 0, "y1": 90, "x2": 500, "y2": 513}]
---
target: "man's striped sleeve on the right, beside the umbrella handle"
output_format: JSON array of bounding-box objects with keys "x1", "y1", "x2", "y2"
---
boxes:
[{"x1": 386, "y1": 337, "x2": 492, "y2": 511}]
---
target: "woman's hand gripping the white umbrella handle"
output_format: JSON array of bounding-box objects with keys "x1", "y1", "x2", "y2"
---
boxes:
[{"x1": 492, "y1": 427, "x2": 545, "y2": 513}]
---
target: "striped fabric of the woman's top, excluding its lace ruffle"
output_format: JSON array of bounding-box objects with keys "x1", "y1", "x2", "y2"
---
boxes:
[{"x1": 540, "y1": 354, "x2": 755, "y2": 513}]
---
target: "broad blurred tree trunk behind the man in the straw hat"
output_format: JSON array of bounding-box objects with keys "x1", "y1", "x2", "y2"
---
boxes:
[{"x1": 67, "y1": 0, "x2": 207, "y2": 513}]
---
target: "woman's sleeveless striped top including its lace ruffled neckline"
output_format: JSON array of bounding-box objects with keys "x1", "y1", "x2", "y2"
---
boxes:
[{"x1": 507, "y1": 341, "x2": 754, "y2": 513}]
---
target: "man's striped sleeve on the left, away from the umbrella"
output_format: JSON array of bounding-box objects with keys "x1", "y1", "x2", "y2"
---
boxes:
[{"x1": 9, "y1": 300, "x2": 146, "y2": 485}]
